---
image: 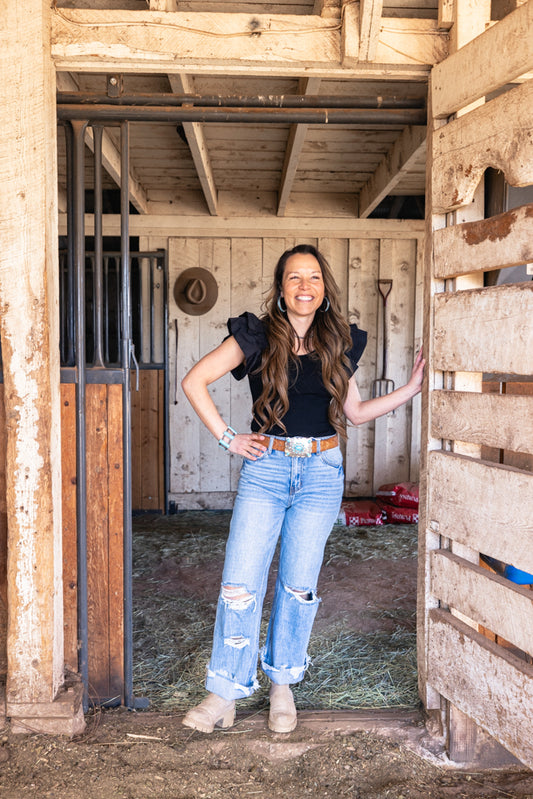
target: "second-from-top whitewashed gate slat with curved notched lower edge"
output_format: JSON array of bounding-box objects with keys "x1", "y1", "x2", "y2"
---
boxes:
[{"x1": 432, "y1": 80, "x2": 533, "y2": 212}]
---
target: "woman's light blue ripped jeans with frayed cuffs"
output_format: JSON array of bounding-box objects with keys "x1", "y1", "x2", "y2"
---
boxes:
[{"x1": 206, "y1": 439, "x2": 344, "y2": 699}]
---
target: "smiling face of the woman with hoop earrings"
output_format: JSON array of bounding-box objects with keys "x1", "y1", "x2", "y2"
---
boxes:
[{"x1": 281, "y1": 253, "x2": 324, "y2": 320}]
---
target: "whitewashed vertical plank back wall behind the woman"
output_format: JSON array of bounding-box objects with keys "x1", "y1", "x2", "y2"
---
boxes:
[{"x1": 168, "y1": 236, "x2": 421, "y2": 508}]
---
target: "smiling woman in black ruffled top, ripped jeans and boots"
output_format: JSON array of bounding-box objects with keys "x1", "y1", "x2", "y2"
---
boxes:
[{"x1": 182, "y1": 245, "x2": 424, "y2": 732}]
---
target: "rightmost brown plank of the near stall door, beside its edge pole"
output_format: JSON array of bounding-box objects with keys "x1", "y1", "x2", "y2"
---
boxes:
[{"x1": 107, "y1": 385, "x2": 124, "y2": 697}]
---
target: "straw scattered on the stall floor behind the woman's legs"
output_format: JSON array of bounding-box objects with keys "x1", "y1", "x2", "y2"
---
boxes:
[{"x1": 133, "y1": 511, "x2": 418, "y2": 711}]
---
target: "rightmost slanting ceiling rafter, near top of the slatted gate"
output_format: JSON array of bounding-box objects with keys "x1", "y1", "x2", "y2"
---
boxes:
[{"x1": 359, "y1": 125, "x2": 426, "y2": 219}]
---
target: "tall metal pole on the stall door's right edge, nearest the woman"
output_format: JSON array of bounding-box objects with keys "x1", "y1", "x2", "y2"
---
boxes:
[{"x1": 120, "y1": 122, "x2": 135, "y2": 708}]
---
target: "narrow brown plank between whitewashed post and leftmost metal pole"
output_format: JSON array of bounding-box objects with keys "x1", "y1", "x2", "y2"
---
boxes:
[{"x1": 61, "y1": 383, "x2": 78, "y2": 672}]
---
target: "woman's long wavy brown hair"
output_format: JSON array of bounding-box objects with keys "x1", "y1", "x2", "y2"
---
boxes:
[{"x1": 253, "y1": 244, "x2": 352, "y2": 438}]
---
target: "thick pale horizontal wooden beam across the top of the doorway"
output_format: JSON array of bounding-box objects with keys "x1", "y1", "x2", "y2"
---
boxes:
[{"x1": 52, "y1": 6, "x2": 448, "y2": 79}]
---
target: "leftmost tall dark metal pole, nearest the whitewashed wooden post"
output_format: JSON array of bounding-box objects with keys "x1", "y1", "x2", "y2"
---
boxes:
[{"x1": 69, "y1": 122, "x2": 89, "y2": 711}]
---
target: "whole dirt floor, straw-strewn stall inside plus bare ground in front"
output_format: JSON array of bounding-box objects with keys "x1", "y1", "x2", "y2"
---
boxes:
[{"x1": 0, "y1": 512, "x2": 533, "y2": 799}]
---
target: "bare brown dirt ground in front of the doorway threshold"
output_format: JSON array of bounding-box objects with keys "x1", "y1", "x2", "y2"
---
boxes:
[{"x1": 0, "y1": 710, "x2": 533, "y2": 799}]
